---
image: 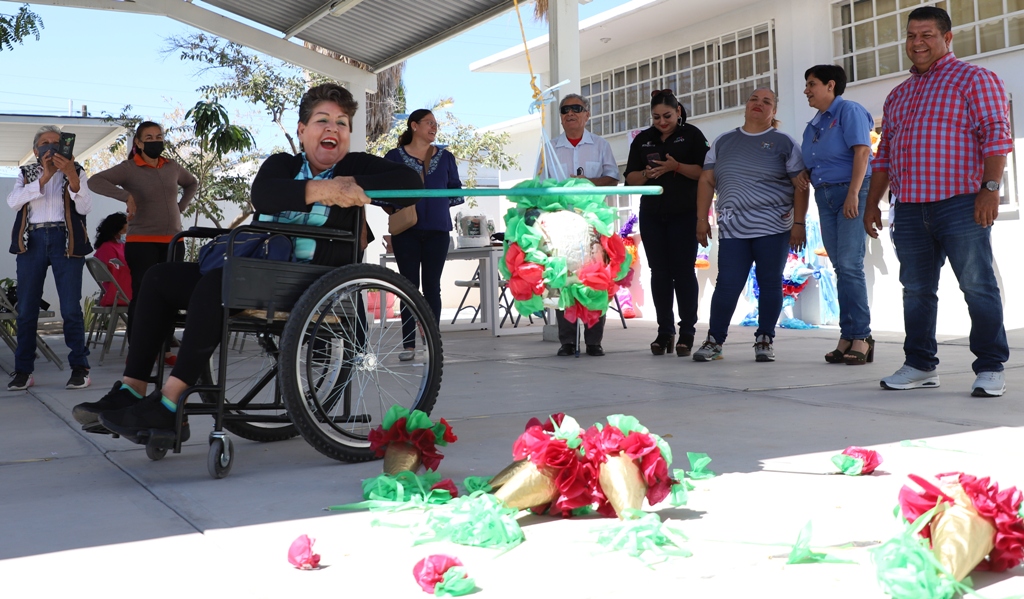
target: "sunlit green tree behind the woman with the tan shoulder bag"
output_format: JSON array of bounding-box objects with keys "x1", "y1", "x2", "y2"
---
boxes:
[{"x1": 367, "y1": 98, "x2": 519, "y2": 192}]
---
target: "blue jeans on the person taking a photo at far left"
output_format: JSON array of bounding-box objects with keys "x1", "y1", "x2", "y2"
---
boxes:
[{"x1": 14, "y1": 227, "x2": 89, "y2": 374}]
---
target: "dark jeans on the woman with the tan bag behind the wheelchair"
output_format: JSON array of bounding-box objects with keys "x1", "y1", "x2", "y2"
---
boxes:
[{"x1": 391, "y1": 228, "x2": 451, "y2": 347}]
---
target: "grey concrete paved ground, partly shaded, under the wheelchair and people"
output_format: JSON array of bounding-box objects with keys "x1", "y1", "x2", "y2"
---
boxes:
[{"x1": 0, "y1": 325, "x2": 1024, "y2": 599}]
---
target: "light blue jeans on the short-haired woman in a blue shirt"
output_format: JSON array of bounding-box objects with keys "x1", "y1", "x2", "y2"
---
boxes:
[{"x1": 814, "y1": 181, "x2": 871, "y2": 339}]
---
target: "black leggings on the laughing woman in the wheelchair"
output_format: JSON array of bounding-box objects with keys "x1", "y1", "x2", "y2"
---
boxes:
[{"x1": 124, "y1": 262, "x2": 223, "y2": 385}]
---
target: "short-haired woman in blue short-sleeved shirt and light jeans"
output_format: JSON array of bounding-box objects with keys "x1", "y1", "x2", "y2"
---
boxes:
[{"x1": 802, "y1": 65, "x2": 874, "y2": 365}]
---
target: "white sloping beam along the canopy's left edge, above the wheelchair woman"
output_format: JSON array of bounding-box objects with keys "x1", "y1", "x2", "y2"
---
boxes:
[{"x1": 0, "y1": 0, "x2": 377, "y2": 93}]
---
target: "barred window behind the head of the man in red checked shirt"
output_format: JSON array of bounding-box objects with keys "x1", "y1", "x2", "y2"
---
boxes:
[{"x1": 831, "y1": 0, "x2": 1024, "y2": 81}]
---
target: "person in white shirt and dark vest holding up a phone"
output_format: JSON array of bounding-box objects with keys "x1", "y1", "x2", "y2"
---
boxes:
[{"x1": 7, "y1": 125, "x2": 92, "y2": 391}]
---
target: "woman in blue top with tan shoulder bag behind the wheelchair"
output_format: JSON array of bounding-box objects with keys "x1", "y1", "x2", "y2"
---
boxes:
[{"x1": 384, "y1": 109, "x2": 465, "y2": 361}]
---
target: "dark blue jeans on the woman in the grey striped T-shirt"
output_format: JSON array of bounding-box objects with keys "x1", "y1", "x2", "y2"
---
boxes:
[{"x1": 708, "y1": 231, "x2": 790, "y2": 343}]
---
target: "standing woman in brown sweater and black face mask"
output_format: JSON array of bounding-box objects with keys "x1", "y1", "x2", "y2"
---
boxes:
[{"x1": 89, "y1": 121, "x2": 199, "y2": 344}]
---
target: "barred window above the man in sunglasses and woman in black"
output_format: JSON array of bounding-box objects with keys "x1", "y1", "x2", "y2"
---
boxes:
[{"x1": 581, "y1": 22, "x2": 774, "y2": 135}]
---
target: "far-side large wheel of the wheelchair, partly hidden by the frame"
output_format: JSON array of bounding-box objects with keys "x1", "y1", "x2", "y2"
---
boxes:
[{"x1": 200, "y1": 333, "x2": 299, "y2": 442}]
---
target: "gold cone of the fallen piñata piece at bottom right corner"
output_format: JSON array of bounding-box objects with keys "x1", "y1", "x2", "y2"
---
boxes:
[{"x1": 929, "y1": 484, "x2": 995, "y2": 582}]
